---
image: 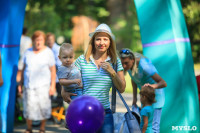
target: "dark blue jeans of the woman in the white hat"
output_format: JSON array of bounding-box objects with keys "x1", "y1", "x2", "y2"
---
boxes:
[{"x1": 97, "y1": 109, "x2": 114, "y2": 133}]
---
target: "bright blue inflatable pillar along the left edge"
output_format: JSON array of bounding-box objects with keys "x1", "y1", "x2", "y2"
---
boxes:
[{"x1": 0, "y1": 0, "x2": 27, "y2": 133}]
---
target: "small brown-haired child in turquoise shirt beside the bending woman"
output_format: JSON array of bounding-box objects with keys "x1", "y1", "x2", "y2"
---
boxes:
[{"x1": 140, "y1": 86, "x2": 155, "y2": 133}]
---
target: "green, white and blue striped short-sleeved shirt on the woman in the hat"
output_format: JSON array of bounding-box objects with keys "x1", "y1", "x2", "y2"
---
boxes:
[{"x1": 75, "y1": 55, "x2": 123, "y2": 109}]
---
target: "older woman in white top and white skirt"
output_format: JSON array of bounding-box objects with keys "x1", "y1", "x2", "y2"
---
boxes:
[{"x1": 19, "y1": 31, "x2": 56, "y2": 133}]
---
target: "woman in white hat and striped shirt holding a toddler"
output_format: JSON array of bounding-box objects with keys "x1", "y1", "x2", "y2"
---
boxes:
[{"x1": 64, "y1": 24, "x2": 126, "y2": 133}]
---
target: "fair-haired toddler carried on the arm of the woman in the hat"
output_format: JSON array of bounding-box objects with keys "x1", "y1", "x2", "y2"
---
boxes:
[{"x1": 57, "y1": 43, "x2": 82, "y2": 101}]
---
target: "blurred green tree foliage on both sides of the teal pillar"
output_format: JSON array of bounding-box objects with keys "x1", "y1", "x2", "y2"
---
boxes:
[{"x1": 24, "y1": 0, "x2": 200, "y2": 62}]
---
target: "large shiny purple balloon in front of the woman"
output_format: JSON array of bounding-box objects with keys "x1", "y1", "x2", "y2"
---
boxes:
[{"x1": 66, "y1": 96, "x2": 104, "y2": 133}]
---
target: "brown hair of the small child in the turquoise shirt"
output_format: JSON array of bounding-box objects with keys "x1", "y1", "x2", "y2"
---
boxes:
[{"x1": 140, "y1": 86, "x2": 156, "y2": 105}]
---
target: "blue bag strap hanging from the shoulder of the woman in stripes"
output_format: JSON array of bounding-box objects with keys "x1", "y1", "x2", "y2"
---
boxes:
[{"x1": 111, "y1": 64, "x2": 134, "y2": 119}]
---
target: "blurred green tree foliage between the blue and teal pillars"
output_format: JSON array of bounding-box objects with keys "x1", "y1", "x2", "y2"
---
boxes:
[{"x1": 25, "y1": 0, "x2": 142, "y2": 51}]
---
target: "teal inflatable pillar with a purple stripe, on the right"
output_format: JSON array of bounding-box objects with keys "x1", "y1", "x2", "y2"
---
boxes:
[{"x1": 134, "y1": 0, "x2": 200, "y2": 133}]
